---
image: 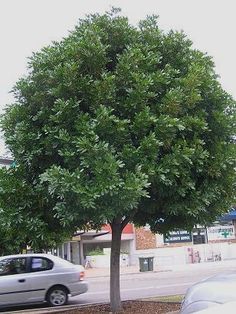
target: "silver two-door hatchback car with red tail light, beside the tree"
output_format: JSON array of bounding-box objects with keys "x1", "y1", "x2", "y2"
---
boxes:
[{"x1": 0, "y1": 254, "x2": 88, "y2": 306}]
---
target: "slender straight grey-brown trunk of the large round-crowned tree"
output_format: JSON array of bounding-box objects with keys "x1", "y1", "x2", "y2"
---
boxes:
[{"x1": 110, "y1": 219, "x2": 122, "y2": 313}]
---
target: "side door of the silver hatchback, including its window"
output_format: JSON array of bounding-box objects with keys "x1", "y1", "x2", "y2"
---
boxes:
[{"x1": 0, "y1": 257, "x2": 31, "y2": 306}]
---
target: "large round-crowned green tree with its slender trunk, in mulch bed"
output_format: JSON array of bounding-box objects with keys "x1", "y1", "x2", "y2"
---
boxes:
[{"x1": 2, "y1": 10, "x2": 235, "y2": 312}]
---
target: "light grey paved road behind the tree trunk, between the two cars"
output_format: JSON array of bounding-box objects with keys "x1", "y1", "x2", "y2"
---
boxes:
[{"x1": 70, "y1": 261, "x2": 236, "y2": 304}]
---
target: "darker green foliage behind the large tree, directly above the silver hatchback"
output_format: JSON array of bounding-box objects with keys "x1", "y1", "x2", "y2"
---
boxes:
[{"x1": 0, "y1": 166, "x2": 68, "y2": 255}]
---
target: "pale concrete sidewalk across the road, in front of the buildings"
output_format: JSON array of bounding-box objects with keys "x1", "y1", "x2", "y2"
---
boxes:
[{"x1": 85, "y1": 259, "x2": 236, "y2": 278}]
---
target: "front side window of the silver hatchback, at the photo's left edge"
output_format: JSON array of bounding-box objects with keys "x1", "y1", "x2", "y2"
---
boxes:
[{"x1": 0, "y1": 257, "x2": 26, "y2": 276}]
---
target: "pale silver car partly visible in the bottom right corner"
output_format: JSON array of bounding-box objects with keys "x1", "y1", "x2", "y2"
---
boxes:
[{"x1": 181, "y1": 272, "x2": 236, "y2": 314}]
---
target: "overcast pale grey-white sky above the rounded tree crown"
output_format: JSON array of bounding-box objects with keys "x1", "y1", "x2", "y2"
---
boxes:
[{"x1": 0, "y1": 0, "x2": 236, "y2": 155}]
